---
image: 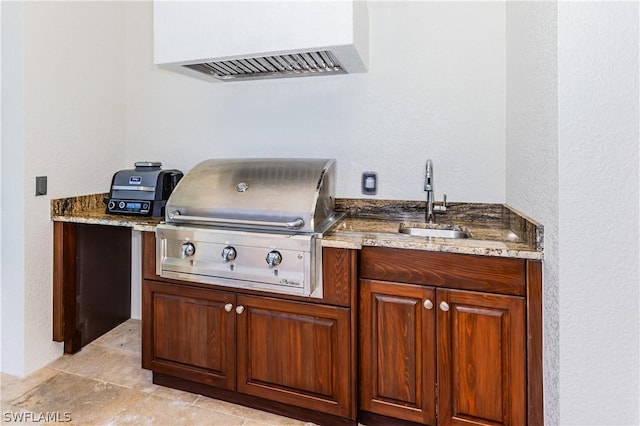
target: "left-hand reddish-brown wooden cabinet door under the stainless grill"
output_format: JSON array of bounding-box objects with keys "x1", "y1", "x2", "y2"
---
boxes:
[{"x1": 142, "y1": 280, "x2": 235, "y2": 389}]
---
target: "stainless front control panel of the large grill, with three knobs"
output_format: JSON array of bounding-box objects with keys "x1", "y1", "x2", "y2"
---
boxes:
[{"x1": 156, "y1": 224, "x2": 322, "y2": 297}]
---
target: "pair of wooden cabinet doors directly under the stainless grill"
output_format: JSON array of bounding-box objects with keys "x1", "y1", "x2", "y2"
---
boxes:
[{"x1": 142, "y1": 280, "x2": 353, "y2": 416}]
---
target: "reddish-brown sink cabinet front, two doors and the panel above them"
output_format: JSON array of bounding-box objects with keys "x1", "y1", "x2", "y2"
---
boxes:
[{"x1": 359, "y1": 249, "x2": 528, "y2": 426}]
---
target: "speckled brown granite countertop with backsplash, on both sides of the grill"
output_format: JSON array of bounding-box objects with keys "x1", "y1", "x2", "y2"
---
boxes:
[{"x1": 51, "y1": 194, "x2": 543, "y2": 259}]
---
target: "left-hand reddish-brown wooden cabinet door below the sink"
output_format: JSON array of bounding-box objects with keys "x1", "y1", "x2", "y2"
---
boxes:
[{"x1": 360, "y1": 280, "x2": 436, "y2": 424}]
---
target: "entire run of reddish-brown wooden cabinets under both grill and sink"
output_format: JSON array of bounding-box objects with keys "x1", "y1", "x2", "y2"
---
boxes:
[{"x1": 143, "y1": 234, "x2": 543, "y2": 426}]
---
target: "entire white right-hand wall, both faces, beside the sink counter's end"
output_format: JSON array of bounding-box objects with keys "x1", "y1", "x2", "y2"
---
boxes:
[{"x1": 506, "y1": 2, "x2": 640, "y2": 425}]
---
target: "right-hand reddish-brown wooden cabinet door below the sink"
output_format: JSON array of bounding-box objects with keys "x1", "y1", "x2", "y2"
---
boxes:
[{"x1": 437, "y1": 290, "x2": 526, "y2": 426}]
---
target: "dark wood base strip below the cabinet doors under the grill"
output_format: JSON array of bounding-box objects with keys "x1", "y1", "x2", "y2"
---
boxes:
[{"x1": 153, "y1": 372, "x2": 357, "y2": 426}]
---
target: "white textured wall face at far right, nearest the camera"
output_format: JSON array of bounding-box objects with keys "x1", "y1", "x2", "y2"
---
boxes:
[{"x1": 558, "y1": 2, "x2": 640, "y2": 424}]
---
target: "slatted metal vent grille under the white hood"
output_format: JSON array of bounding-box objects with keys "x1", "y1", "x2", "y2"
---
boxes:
[{"x1": 185, "y1": 50, "x2": 345, "y2": 80}]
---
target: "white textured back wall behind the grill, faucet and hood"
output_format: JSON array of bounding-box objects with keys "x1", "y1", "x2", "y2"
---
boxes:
[{"x1": 127, "y1": 1, "x2": 505, "y2": 202}]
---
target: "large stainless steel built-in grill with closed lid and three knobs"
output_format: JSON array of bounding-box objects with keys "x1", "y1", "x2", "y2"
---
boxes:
[{"x1": 156, "y1": 159, "x2": 339, "y2": 297}]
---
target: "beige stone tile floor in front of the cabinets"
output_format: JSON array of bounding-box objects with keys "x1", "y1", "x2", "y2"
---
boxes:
[{"x1": 0, "y1": 320, "x2": 310, "y2": 426}]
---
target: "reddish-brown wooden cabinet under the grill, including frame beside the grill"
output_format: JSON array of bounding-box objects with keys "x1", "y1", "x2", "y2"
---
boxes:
[{"x1": 142, "y1": 235, "x2": 357, "y2": 423}]
